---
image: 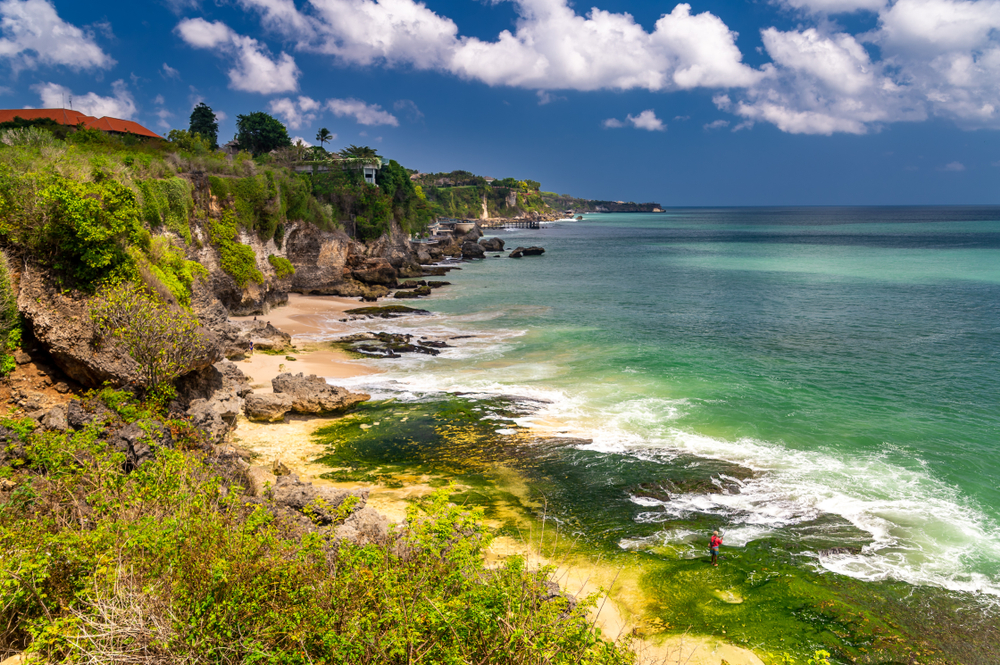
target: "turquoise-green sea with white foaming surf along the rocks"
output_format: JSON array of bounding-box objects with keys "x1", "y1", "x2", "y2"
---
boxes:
[{"x1": 334, "y1": 208, "x2": 1000, "y2": 602}]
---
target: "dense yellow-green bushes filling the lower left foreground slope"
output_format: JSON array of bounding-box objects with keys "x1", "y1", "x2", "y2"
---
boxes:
[{"x1": 0, "y1": 391, "x2": 633, "y2": 665}]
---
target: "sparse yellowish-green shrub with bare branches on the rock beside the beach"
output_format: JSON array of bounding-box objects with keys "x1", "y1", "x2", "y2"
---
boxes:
[{"x1": 90, "y1": 282, "x2": 218, "y2": 395}]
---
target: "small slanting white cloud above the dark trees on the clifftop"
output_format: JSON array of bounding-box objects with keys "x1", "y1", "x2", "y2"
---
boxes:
[{"x1": 177, "y1": 18, "x2": 301, "y2": 95}]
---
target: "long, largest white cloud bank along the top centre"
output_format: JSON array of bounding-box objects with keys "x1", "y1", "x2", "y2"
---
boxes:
[{"x1": 238, "y1": 0, "x2": 760, "y2": 91}]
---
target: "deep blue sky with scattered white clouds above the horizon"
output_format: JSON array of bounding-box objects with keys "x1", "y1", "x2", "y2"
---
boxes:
[{"x1": 0, "y1": 0, "x2": 1000, "y2": 206}]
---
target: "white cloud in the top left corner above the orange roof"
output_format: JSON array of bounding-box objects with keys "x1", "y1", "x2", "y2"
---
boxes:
[{"x1": 0, "y1": 0, "x2": 115, "y2": 70}]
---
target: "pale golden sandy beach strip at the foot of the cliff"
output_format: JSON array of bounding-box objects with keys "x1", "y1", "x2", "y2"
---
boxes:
[{"x1": 231, "y1": 294, "x2": 763, "y2": 665}]
